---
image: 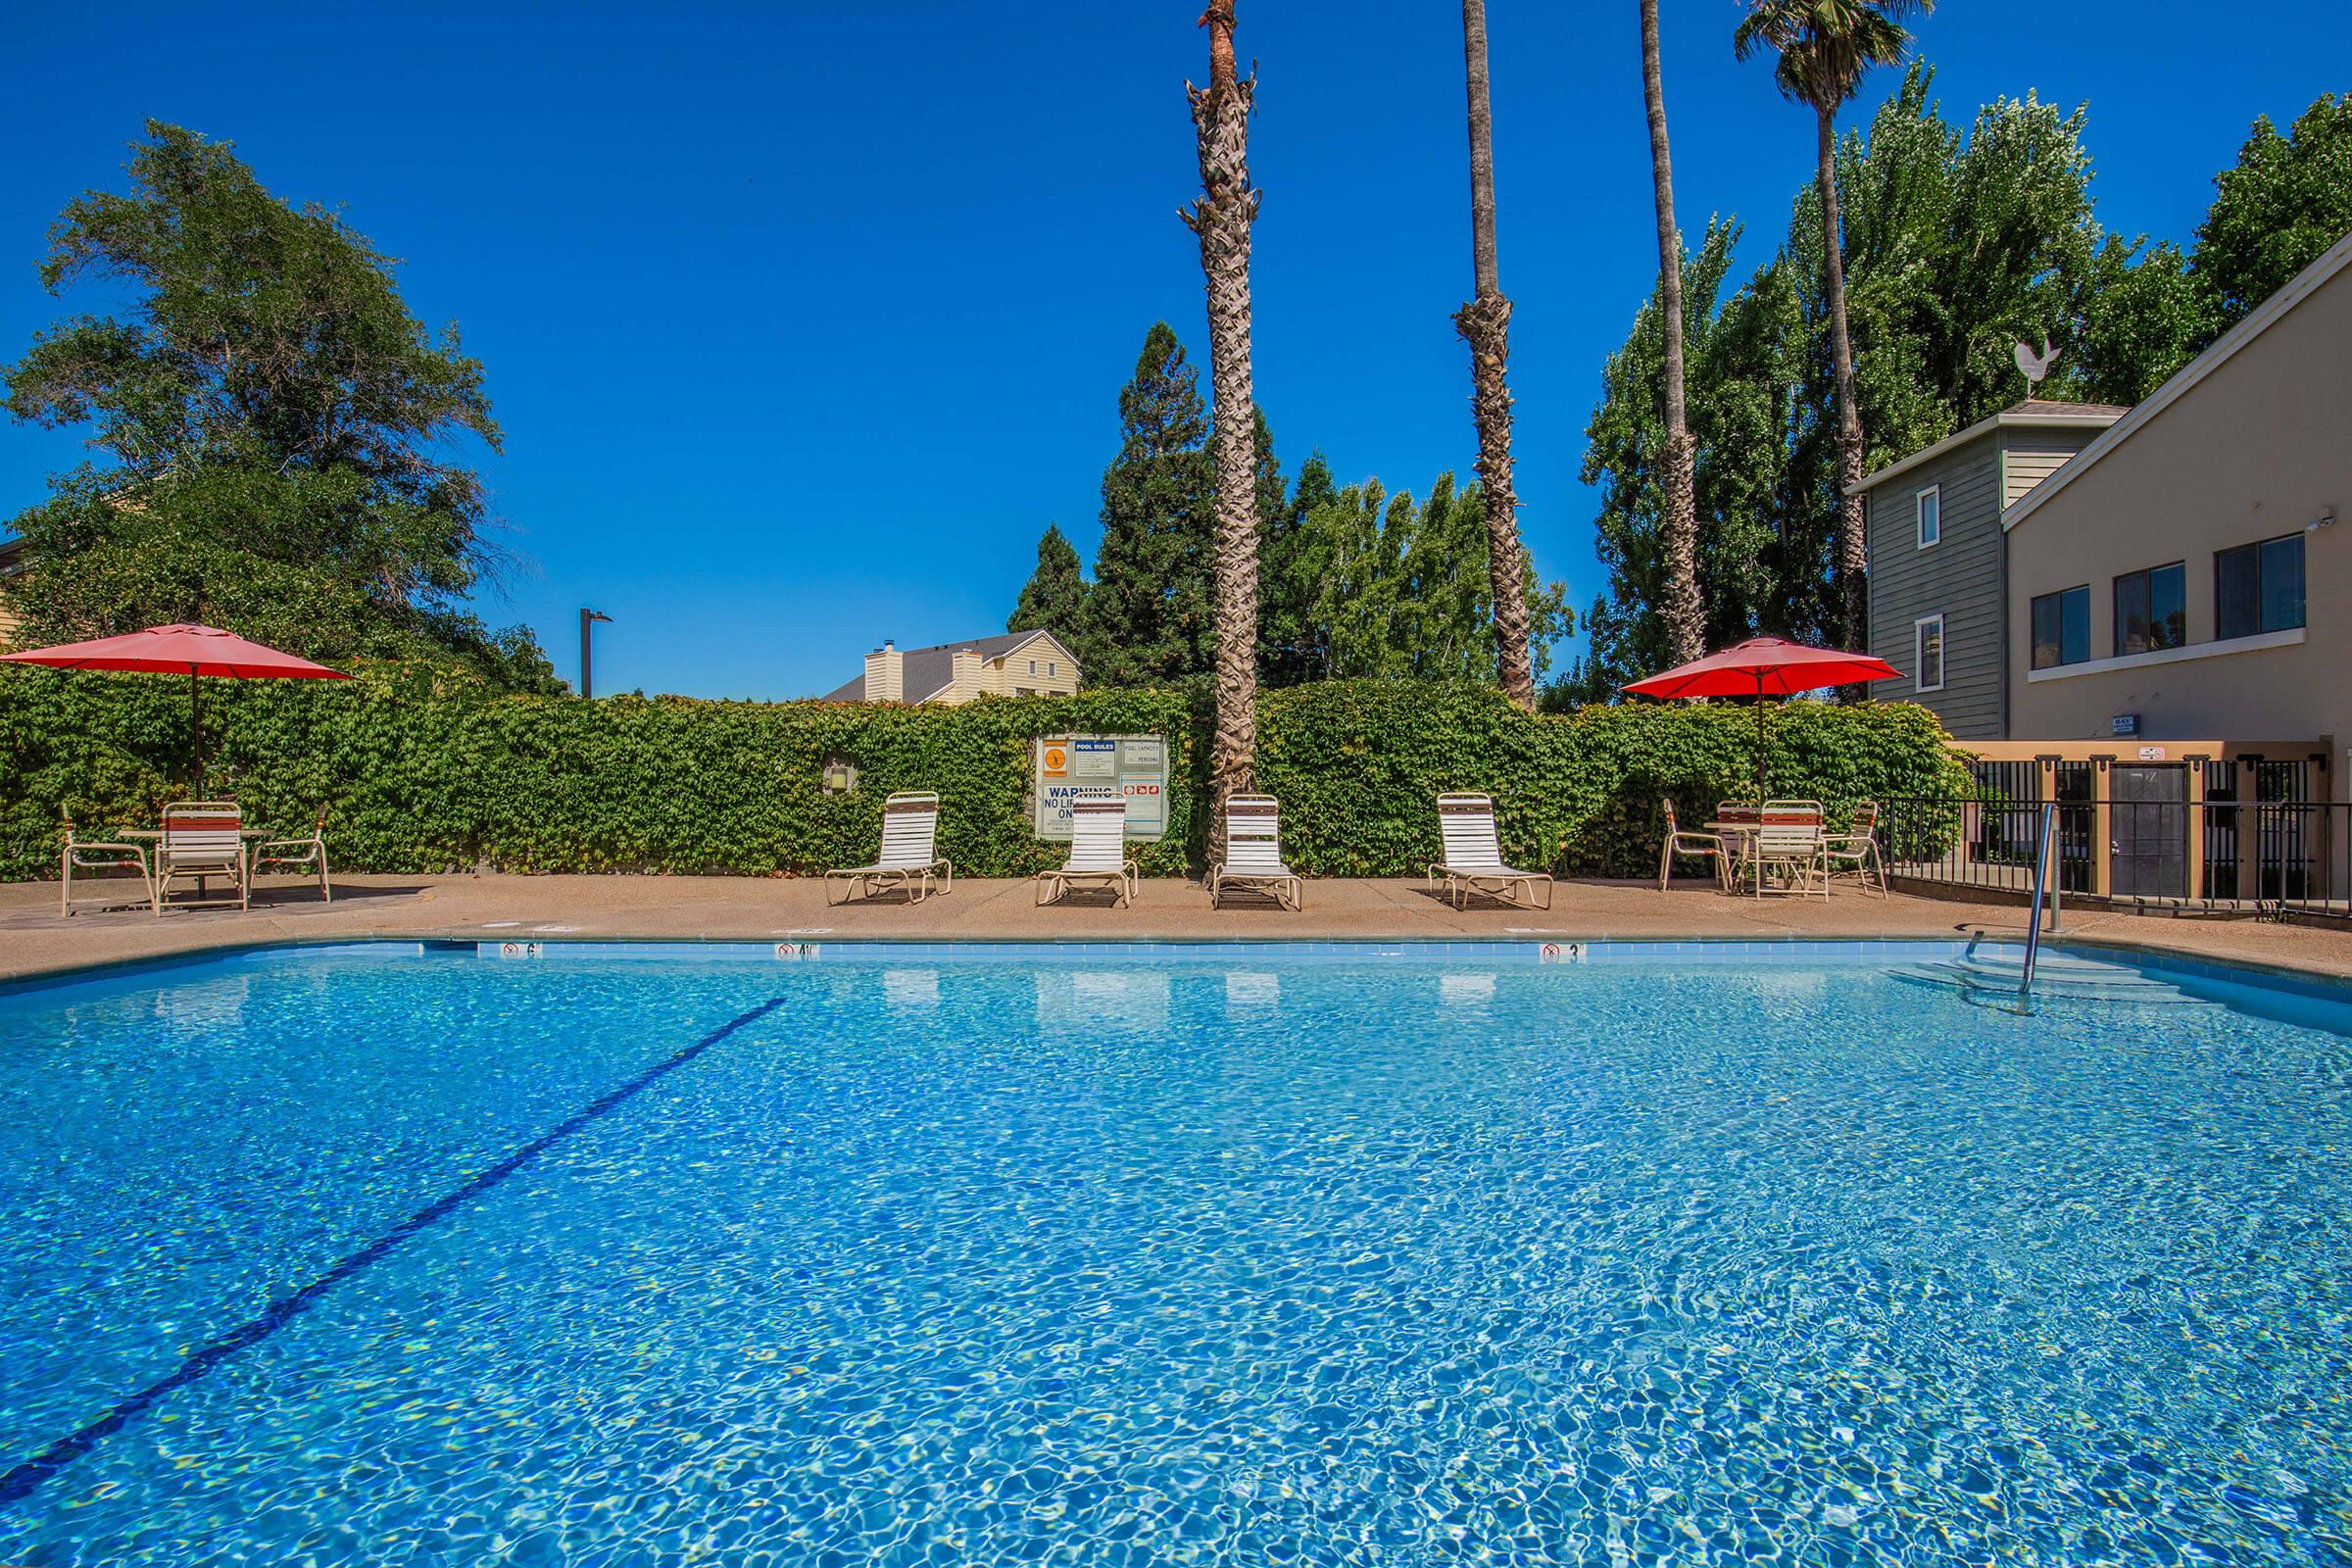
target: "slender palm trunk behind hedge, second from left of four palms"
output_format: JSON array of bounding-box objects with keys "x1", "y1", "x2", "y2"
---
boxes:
[{"x1": 1453, "y1": 0, "x2": 1536, "y2": 710}]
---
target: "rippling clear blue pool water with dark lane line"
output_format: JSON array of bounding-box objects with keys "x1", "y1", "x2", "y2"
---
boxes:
[{"x1": 0, "y1": 950, "x2": 2352, "y2": 1568}]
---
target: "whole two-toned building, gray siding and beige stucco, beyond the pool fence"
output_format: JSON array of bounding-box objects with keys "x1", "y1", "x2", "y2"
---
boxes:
[{"x1": 1856, "y1": 235, "x2": 2352, "y2": 912}]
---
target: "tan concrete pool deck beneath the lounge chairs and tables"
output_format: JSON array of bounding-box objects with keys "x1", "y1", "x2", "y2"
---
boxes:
[{"x1": 14, "y1": 874, "x2": 2352, "y2": 978}]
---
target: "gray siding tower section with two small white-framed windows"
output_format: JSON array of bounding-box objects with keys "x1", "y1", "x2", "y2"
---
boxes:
[{"x1": 1856, "y1": 400, "x2": 2127, "y2": 741}]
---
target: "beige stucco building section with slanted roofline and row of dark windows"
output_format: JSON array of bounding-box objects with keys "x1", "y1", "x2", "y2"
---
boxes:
[{"x1": 2001, "y1": 237, "x2": 2352, "y2": 761}]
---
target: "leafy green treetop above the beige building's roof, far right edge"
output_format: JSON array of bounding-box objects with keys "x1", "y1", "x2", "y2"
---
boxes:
[{"x1": 2189, "y1": 92, "x2": 2352, "y2": 341}]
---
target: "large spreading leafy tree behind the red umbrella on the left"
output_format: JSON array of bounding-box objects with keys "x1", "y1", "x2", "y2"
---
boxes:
[{"x1": 5, "y1": 120, "x2": 555, "y2": 689}]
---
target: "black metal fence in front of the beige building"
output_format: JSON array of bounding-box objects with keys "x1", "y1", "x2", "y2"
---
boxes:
[{"x1": 1880, "y1": 799, "x2": 2352, "y2": 917}]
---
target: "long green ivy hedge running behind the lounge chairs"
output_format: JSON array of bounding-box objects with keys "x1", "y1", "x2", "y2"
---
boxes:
[{"x1": 0, "y1": 665, "x2": 1966, "y2": 879}]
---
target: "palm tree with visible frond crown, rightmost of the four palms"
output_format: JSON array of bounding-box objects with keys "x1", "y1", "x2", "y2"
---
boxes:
[{"x1": 1731, "y1": 0, "x2": 1936, "y2": 649}]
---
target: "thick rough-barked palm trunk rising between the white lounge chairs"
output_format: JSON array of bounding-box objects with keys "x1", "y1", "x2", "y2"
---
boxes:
[{"x1": 1183, "y1": 0, "x2": 1258, "y2": 822}]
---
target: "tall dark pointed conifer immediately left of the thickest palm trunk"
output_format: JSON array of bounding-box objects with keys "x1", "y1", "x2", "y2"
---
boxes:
[{"x1": 1080, "y1": 322, "x2": 1216, "y2": 686}]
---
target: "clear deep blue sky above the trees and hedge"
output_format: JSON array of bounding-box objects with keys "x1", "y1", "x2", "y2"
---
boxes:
[{"x1": 0, "y1": 0, "x2": 2352, "y2": 698}]
